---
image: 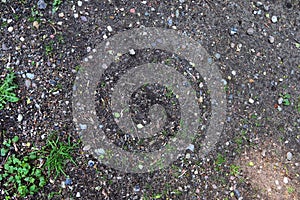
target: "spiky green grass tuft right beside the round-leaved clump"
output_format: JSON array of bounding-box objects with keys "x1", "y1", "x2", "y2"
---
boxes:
[{"x1": 37, "y1": 134, "x2": 77, "y2": 178}]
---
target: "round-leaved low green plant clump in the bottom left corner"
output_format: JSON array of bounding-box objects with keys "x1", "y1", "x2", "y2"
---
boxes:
[{"x1": 0, "y1": 136, "x2": 46, "y2": 199}]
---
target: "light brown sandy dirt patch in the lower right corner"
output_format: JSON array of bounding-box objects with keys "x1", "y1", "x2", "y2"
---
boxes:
[{"x1": 236, "y1": 139, "x2": 300, "y2": 200}]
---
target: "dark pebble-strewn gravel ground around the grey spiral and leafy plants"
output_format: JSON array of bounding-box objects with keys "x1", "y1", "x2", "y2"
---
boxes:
[{"x1": 0, "y1": 0, "x2": 300, "y2": 200}]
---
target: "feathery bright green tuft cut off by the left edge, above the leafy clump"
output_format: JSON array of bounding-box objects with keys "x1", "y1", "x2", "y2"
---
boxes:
[{"x1": 0, "y1": 72, "x2": 19, "y2": 110}]
